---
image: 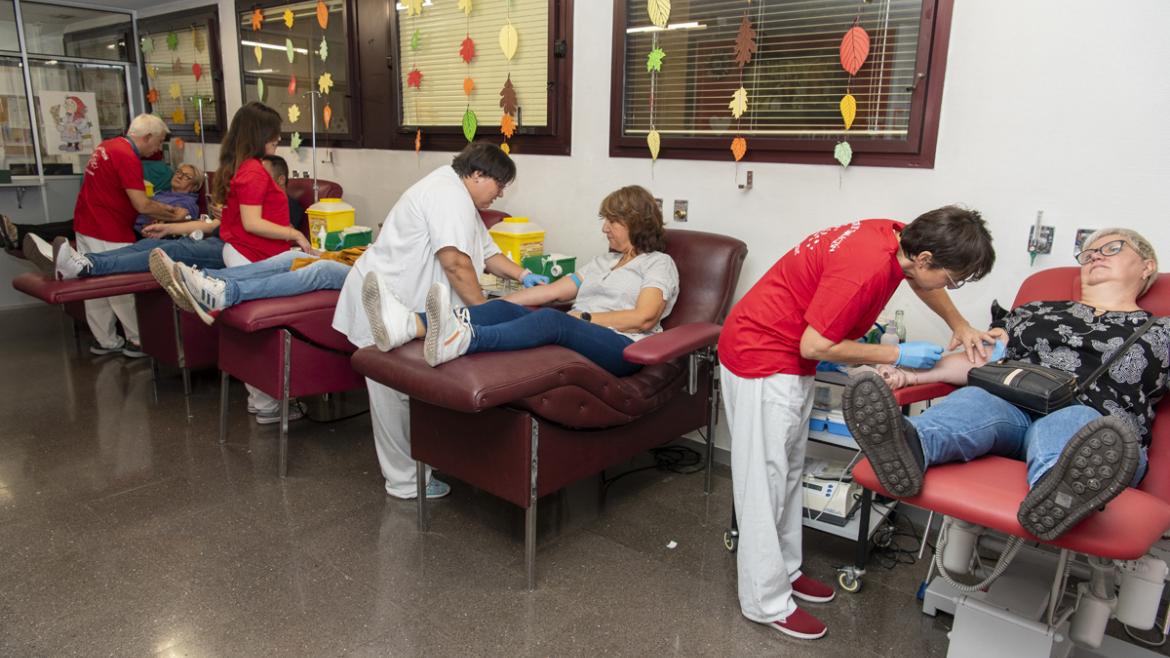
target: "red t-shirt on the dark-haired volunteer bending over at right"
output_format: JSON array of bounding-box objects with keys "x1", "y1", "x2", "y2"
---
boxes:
[{"x1": 720, "y1": 219, "x2": 906, "y2": 378}]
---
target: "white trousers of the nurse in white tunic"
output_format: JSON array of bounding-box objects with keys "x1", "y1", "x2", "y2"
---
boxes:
[{"x1": 366, "y1": 378, "x2": 431, "y2": 498}]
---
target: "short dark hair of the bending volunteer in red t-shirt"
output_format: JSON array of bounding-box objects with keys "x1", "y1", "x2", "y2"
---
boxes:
[{"x1": 902, "y1": 206, "x2": 996, "y2": 281}]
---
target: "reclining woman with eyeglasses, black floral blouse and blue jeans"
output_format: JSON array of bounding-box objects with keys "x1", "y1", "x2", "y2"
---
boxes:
[{"x1": 845, "y1": 228, "x2": 1170, "y2": 540}]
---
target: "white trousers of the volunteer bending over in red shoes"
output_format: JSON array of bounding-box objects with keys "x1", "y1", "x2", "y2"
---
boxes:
[{"x1": 721, "y1": 368, "x2": 813, "y2": 623}]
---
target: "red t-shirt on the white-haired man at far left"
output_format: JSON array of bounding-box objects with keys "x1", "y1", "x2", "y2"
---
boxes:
[{"x1": 74, "y1": 137, "x2": 146, "y2": 242}]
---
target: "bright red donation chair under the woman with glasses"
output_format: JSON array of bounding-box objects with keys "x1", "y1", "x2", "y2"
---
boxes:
[{"x1": 853, "y1": 267, "x2": 1170, "y2": 657}]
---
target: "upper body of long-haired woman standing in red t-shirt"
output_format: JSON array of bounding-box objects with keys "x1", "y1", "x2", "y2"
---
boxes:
[{"x1": 212, "y1": 102, "x2": 314, "y2": 267}]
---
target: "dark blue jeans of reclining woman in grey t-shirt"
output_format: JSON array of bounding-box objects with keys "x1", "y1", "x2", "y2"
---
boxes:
[{"x1": 456, "y1": 300, "x2": 642, "y2": 377}]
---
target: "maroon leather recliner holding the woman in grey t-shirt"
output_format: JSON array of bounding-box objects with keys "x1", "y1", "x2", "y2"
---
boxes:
[{"x1": 353, "y1": 229, "x2": 748, "y2": 589}]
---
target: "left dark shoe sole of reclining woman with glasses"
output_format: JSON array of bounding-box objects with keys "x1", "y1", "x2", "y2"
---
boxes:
[{"x1": 844, "y1": 372, "x2": 922, "y2": 498}]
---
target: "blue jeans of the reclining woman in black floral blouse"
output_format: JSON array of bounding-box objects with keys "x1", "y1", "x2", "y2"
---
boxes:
[{"x1": 909, "y1": 386, "x2": 1147, "y2": 487}]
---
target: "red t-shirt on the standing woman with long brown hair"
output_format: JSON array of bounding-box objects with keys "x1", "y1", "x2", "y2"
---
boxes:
[{"x1": 220, "y1": 158, "x2": 289, "y2": 262}]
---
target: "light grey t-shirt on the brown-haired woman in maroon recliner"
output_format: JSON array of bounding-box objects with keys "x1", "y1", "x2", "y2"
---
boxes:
[{"x1": 573, "y1": 252, "x2": 679, "y2": 341}]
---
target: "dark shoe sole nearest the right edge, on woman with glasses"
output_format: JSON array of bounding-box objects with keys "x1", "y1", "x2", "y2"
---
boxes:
[{"x1": 1016, "y1": 416, "x2": 1141, "y2": 541}]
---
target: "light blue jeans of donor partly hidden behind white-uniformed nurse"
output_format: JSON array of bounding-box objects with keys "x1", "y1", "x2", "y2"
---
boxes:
[{"x1": 204, "y1": 252, "x2": 350, "y2": 306}]
